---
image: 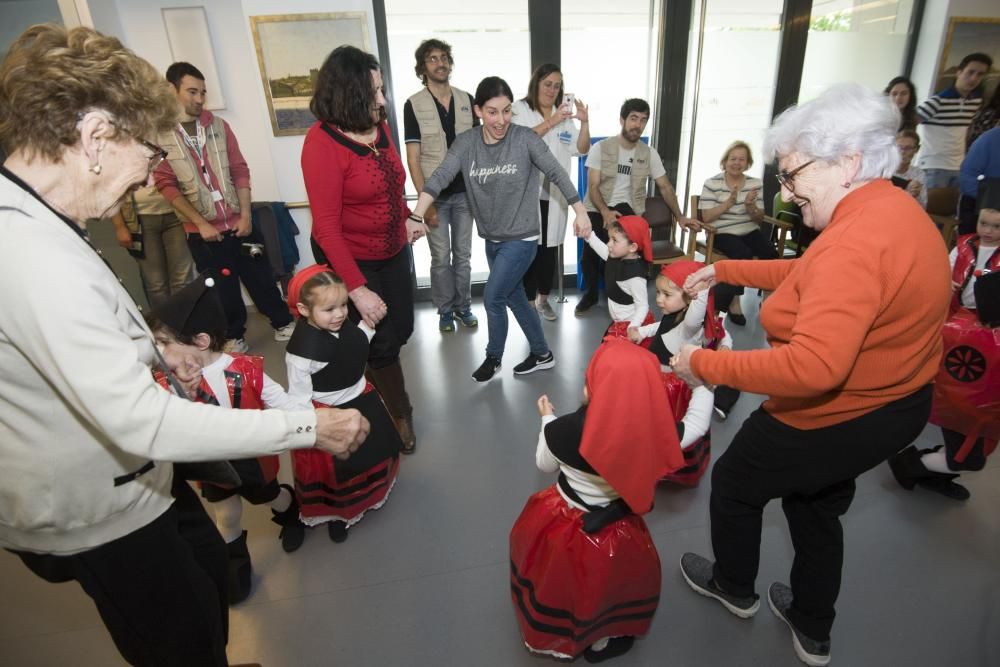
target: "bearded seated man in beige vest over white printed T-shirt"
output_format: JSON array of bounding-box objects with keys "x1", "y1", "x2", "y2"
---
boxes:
[{"x1": 575, "y1": 98, "x2": 694, "y2": 315}]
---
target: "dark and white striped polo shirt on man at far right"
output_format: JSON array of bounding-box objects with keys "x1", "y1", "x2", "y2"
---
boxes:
[{"x1": 917, "y1": 86, "x2": 983, "y2": 171}]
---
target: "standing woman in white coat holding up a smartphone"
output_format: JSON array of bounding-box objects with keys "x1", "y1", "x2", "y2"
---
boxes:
[{"x1": 513, "y1": 63, "x2": 590, "y2": 321}]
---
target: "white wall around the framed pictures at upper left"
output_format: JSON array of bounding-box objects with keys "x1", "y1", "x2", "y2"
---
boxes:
[{"x1": 89, "y1": 0, "x2": 377, "y2": 264}]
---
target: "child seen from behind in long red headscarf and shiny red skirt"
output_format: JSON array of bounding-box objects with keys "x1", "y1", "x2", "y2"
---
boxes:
[{"x1": 510, "y1": 339, "x2": 684, "y2": 662}]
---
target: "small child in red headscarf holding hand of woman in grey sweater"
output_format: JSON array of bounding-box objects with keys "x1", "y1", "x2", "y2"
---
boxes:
[{"x1": 587, "y1": 215, "x2": 653, "y2": 347}]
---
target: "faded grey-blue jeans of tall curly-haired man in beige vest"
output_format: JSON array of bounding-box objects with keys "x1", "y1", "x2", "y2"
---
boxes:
[{"x1": 427, "y1": 193, "x2": 472, "y2": 315}]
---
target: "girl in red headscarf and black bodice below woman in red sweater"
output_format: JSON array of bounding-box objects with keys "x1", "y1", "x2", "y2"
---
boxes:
[{"x1": 285, "y1": 264, "x2": 403, "y2": 542}]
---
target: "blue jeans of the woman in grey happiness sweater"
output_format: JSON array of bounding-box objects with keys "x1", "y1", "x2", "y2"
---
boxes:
[{"x1": 483, "y1": 241, "x2": 549, "y2": 359}]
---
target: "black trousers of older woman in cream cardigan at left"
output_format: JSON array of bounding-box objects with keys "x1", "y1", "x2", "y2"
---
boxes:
[{"x1": 15, "y1": 478, "x2": 229, "y2": 667}]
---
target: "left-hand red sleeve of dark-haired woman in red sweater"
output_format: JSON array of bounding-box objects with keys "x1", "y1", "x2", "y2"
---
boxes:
[{"x1": 302, "y1": 125, "x2": 366, "y2": 291}]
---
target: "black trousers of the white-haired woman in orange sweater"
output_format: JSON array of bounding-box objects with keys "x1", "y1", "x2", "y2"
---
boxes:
[{"x1": 709, "y1": 385, "x2": 931, "y2": 641}]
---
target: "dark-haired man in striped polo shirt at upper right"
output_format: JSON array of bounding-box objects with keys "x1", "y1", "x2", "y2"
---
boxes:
[{"x1": 917, "y1": 53, "x2": 993, "y2": 188}]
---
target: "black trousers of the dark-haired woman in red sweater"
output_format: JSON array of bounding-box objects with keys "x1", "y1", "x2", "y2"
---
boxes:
[{"x1": 312, "y1": 238, "x2": 416, "y2": 370}]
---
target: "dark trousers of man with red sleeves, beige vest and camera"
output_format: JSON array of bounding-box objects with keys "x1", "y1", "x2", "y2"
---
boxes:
[{"x1": 187, "y1": 231, "x2": 292, "y2": 338}]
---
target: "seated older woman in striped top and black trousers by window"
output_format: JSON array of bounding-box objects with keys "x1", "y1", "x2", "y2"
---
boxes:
[{"x1": 698, "y1": 141, "x2": 778, "y2": 324}]
